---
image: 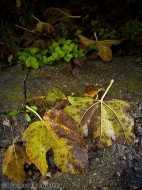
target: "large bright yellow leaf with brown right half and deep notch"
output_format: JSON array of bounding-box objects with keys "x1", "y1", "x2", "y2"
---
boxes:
[{"x1": 23, "y1": 109, "x2": 88, "y2": 176}]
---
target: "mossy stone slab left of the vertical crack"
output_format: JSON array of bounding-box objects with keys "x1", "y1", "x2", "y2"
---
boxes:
[{"x1": 0, "y1": 66, "x2": 27, "y2": 113}]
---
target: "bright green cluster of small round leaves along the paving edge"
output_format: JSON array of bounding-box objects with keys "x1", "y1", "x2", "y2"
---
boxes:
[{"x1": 16, "y1": 38, "x2": 84, "y2": 69}]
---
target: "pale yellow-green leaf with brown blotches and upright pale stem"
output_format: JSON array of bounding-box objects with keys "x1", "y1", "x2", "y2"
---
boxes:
[{"x1": 64, "y1": 80, "x2": 134, "y2": 148}]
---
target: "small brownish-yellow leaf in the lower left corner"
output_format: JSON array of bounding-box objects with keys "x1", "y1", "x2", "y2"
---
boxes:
[{"x1": 2, "y1": 144, "x2": 28, "y2": 183}]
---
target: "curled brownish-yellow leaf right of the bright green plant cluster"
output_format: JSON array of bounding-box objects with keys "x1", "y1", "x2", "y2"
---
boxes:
[{"x1": 79, "y1": 34, "x2": 123, "y2": 62}]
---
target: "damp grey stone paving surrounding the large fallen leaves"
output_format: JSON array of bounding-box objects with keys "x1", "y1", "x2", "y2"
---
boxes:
[{"x1": 0, "y1": 57, "x2": 142, "y2": 190}]
